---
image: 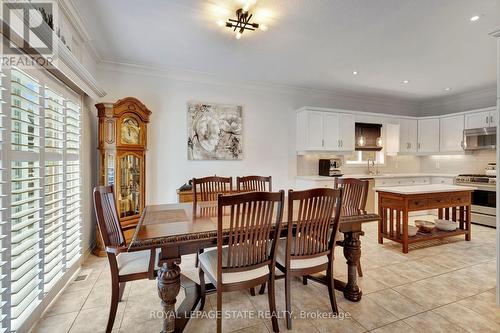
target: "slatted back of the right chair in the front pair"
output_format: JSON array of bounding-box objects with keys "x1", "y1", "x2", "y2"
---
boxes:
[{"x1": 287, "y1": 188, "x2": 341, "y2": 259}]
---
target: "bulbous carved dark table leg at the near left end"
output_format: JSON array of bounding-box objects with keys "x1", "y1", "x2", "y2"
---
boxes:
[{"x1": 158, "y1": 259, "x2": 181, "y2": 333}]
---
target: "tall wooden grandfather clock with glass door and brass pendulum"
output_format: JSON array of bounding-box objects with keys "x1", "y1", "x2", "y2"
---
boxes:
[{"x1": 94, "y1": 97, "x2": 151, "y2": 256}]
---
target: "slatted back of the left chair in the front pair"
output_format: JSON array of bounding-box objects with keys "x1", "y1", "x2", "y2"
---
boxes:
[{"x1": 217, "y1": 191, "x2": 284, "y2": 271}]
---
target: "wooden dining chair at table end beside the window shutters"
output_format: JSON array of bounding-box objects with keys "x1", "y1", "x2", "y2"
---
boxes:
[{"x1": 94, "y1": 186, "x2": 158, "y2": 333}]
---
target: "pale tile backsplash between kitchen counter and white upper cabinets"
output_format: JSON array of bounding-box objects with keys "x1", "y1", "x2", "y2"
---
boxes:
[{"x1": 297, "y1": 151, "x2": 495, "y2": 176}]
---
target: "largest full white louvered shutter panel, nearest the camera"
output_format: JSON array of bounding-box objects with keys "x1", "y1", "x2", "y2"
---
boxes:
[{"x1": 10, "y1": 69, "x2": 43, "y2": 322}]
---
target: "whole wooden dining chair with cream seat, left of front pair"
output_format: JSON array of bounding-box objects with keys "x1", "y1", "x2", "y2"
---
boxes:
[{"x1": 198, "y1": 191, "x2": 285, "y2": 333}]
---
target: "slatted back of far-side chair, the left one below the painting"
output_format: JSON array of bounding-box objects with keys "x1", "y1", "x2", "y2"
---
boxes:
[{"x1": 192, "y1": 176, "x2": 233, "y2": 217}]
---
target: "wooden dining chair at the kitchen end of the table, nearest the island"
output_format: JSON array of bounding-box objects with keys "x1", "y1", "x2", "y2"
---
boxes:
[{"x1": 335, "y1": 178, "x2": 369, "y2": 277}]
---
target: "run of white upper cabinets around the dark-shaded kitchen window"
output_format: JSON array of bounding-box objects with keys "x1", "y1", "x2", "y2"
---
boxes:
[{"x1": 297, "y1": 107, "x2": 498, "y2": 155}]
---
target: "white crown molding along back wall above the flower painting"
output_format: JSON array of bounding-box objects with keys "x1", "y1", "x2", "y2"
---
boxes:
[{"x1": 98, "y1": 60, "x2": 420, "y2": 111}]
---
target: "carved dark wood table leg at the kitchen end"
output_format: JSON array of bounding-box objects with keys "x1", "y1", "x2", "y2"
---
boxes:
[{"x1": 344, "y1": 232, "x2": 362, "y2": 302}]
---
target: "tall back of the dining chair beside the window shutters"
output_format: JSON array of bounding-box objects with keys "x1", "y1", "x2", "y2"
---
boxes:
[{"x1": 94, "y1": 185, "x2": 125, "y2": 246}]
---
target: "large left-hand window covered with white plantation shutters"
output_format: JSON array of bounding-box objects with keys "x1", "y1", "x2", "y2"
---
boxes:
[{"x1": 0, "y1": 68, "x2": 81, "y2": 332}]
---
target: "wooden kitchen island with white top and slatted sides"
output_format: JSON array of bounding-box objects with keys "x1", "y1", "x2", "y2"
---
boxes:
[{"x1": 374, "y1": 184, "x2": 474, "y2": 253}]
